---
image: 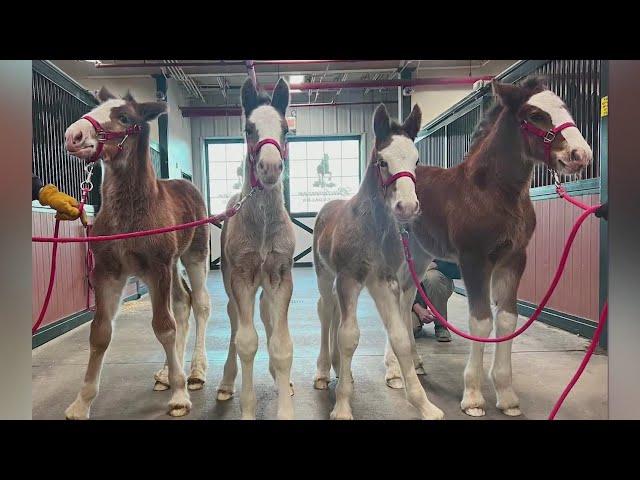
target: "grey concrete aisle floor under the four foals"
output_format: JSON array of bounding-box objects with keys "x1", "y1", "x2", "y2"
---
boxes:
[{"x1": 32, "y1": 268, "x2": 607, "y2": 421}]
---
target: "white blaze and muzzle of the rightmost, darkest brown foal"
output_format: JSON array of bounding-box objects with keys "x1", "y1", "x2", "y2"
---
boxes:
[{"x1": 527, "y1": 90, "x2": 593, "y2": 174}]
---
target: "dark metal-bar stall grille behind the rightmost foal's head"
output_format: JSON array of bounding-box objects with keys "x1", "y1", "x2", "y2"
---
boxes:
[{"x1": 417, "y1": 60, "x2": 603, "y2": 194}]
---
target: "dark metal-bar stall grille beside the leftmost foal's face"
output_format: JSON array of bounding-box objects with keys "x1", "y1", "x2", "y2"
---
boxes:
[{"x1": 32, "y1": 61, "x2": 100, "y2": 209}]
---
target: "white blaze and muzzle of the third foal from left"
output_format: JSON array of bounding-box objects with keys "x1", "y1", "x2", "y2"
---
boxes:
[{"x1": 378, "y1": 135, "x2": 420, "y2": 221}]
